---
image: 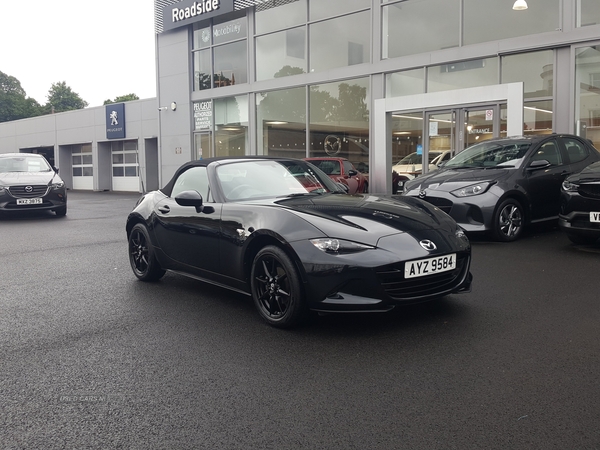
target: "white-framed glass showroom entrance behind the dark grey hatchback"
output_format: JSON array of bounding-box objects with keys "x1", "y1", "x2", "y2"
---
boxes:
[{"x1": 369, "y1": 82, "x2": 523, "y2": 194}]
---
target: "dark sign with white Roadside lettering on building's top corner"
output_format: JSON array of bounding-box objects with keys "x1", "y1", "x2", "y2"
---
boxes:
[{"x1": 163, "y1": 0, "x2": 233, "y2": 31}]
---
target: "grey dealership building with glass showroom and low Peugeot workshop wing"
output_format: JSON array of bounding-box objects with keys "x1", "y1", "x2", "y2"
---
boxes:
[{"x1": 0, "y1": 0, "x2": 600, "y2": 193}]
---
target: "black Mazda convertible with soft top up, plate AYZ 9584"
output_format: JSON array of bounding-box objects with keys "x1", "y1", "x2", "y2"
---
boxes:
[{"x1": 126, "y1": 157, "x2": 472, "y2": 327}]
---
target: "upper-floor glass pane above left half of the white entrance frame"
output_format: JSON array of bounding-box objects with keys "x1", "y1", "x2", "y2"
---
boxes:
[{"x1": 381, "y1": 0, "x2": 460, "y2": 59}]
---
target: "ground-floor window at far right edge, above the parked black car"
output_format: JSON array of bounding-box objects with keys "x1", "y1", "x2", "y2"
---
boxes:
[{"x1": 575, "y1": 46, "x2": 600, "y2": 148}]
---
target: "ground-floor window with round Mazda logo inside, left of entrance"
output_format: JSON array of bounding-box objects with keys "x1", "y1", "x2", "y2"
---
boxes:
[{"x1": 308, "y1": 78, "x2": 370, "y2": 172}]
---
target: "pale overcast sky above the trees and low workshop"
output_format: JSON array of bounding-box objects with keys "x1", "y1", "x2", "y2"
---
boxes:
[{"x1": 0, "y1": 0, "x2": 156, "y2": 106}]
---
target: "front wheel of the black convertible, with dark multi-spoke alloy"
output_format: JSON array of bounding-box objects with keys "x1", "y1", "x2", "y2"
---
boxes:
[{"x1": 250, "y1": 245, "x2": 307, "y2": 328}]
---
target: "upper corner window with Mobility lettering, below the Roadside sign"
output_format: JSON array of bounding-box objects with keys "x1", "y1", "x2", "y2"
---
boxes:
[{"x1": 193, "y1": 11, "x2": 248, "y2": 91}]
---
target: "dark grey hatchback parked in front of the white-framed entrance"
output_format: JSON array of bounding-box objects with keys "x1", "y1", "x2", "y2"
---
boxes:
[{"x1": 404, "y1": 134, "x2": 600, "y2": 241}]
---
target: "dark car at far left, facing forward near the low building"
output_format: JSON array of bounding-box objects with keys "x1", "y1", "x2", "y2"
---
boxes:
[{"x1": 0, "y1": 153, "x2": 67, "y2": 216}]
